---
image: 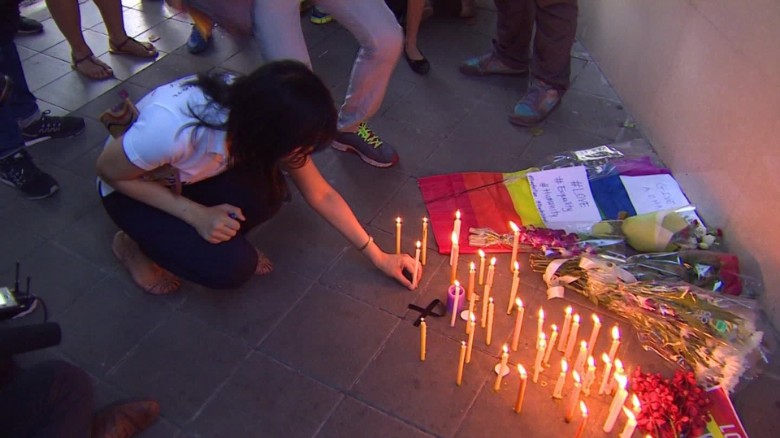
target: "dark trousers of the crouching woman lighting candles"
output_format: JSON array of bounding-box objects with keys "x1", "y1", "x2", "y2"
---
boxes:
[{"x1": 103, "y1": 169, "x2": 281, "y2": 289}]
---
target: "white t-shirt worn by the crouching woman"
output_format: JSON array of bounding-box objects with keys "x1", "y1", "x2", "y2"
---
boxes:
[{"x1": 100, "y1": 76, "x2": 228, "y2": 196}]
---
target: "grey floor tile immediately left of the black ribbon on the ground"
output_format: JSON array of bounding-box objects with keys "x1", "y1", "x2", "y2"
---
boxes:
[{"x1": 260, "y1": 286, "x2": 398, "y2": 389}]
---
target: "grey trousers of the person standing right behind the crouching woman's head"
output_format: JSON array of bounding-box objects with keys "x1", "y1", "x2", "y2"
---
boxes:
[{"x1": 254, "y1": 0, "x2": 403, "y2": 132}]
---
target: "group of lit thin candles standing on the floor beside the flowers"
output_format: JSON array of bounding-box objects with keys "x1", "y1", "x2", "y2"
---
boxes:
[{"x1": 396, "y1": 211, "x2": 639, "y2": 438}]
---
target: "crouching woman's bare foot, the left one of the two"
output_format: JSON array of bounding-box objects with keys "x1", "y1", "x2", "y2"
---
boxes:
[{"x1": 111, "y1": 231, "x2": 181, "y2": 295}]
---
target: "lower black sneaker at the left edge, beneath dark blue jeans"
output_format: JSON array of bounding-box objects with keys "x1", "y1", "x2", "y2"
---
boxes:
[{"x1": 0, "y1": 149, "x2": 60, "y2": 199}]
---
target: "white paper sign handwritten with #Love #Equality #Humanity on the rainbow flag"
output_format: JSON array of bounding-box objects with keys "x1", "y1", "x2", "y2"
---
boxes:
[{"x1": 528, "y1": 166, "x2": 601, "y2": 228}]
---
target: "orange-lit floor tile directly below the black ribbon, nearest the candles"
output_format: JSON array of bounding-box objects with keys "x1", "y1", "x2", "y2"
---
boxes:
[{"x1": 352, "y1": 321, "x2": 494, "y2": 436}]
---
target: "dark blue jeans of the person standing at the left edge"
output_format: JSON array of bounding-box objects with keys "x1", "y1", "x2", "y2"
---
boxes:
[{"x1": 0, "y1": 39, "x2": 38, "y2": 158}]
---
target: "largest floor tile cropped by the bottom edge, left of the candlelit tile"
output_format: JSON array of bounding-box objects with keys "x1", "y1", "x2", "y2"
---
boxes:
[{"x1": 188, "y1": 353, "x2": 341, "y2": 438}]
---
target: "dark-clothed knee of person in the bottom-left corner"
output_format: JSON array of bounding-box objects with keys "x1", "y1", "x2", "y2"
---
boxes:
[{"x1": 0, "y1": 361, "x2": 94, "y2": 437}]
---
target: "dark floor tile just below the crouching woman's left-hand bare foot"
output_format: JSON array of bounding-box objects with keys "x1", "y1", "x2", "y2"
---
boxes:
[{"x1": 57, "y1": 277, "x2": 170, "y2": 377}]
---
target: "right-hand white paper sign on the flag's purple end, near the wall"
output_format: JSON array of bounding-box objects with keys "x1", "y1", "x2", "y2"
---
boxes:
[{"x1": 620, "y1": 174, "x2": 690, "y2": 214}]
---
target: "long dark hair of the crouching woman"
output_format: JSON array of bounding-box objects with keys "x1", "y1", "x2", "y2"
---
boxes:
[{"x1": 190, "y1": 61, "x2": 338, "y2": 202}]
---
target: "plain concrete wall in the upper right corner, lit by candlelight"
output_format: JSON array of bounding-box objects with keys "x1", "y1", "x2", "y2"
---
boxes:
[{"x1": 578, "y1": 0, "x2": 780, "y2": 327}]
